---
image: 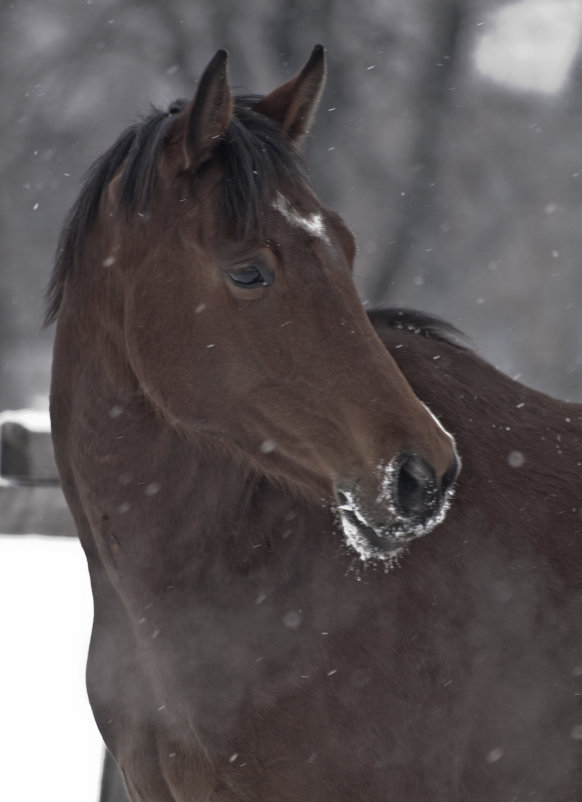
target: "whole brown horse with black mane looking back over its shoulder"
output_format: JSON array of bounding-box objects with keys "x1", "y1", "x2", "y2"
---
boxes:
[{"x1": 47, "y1": 47, "x2": 582, "y2": 802}]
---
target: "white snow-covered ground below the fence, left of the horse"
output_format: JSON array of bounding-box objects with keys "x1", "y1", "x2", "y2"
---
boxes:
[{"x1": 0, "y1": 535, "x2": 103, "y2": 802}]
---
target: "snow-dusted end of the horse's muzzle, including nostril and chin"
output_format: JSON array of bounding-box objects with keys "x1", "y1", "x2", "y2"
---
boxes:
[{"x1": 336, "y1": 453, "x2": 460, "y2": 562}]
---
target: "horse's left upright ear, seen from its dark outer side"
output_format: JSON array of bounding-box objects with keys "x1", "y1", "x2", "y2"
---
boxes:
[{"x1": 181, "y1": 50, "x2": 233, "y2": 170}]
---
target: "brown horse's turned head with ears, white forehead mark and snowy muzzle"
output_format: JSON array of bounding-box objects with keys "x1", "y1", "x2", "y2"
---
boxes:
[{"x1": 53, "y1": 47, "x2": 458, "y2": 558}]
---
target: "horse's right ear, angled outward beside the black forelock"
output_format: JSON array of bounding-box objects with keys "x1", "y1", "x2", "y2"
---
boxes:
[{"x1": 253, "y1": 45, "x2": 325, "y2": 144}]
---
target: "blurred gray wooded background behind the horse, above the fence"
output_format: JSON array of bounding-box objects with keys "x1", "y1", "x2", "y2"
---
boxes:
[{"x1": 0, "y1": 0, "x2": 582, "y2": 410}]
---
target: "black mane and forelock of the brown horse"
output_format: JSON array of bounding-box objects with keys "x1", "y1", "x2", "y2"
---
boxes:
[{"x1": 45, "y1": 95, "x2": 306, "y2": 325}]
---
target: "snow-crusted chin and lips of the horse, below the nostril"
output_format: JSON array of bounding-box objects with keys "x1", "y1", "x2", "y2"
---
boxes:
[{"x1": 336, "y1": 490, "x2": 453, "y2": 565}]
